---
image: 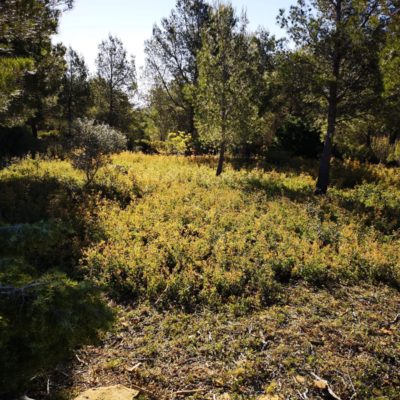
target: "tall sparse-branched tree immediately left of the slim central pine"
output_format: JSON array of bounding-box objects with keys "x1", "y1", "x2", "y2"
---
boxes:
[{"x1": 145, "y1": 0, "x2": 211, "y2": 148}]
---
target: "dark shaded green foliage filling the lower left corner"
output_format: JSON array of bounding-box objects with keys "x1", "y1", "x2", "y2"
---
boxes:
[{"x1": 0, "y1": 268, "x2": 112, "y2": 396}]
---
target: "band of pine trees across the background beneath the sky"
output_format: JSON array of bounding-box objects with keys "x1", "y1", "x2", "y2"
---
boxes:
[{"x1": 0, "y1": 0, "x2": 400, "y2": 189}]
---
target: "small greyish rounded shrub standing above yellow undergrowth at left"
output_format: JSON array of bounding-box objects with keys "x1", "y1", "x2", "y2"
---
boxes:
[{"x1": 71, "y1": 119, "x2": 127, "y2": 185}]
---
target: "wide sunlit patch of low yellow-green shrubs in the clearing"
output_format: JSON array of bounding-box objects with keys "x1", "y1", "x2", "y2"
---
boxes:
[{"x1": 73, "y1": 153, "x2": 400, "y2": 310}]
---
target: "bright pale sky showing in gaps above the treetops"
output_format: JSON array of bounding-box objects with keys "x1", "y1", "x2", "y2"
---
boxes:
[{"x1": 53, "y1": 0, "x2": 295, "y2": 74}]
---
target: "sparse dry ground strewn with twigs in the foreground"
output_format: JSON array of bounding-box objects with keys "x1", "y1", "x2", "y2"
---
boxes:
[{"x1": 54, "y1": 285, "x2": 400, "y2": 400}]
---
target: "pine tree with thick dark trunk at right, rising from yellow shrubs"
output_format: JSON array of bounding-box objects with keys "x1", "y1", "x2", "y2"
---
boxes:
[{"x1": 279, "y1": 0, "x2": 382, "y2": 194}]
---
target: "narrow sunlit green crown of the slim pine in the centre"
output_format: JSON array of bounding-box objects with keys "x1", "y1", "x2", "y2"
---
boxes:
[{"x1": 196, "y1": 4, "x2": 262, "y2": 159}]
